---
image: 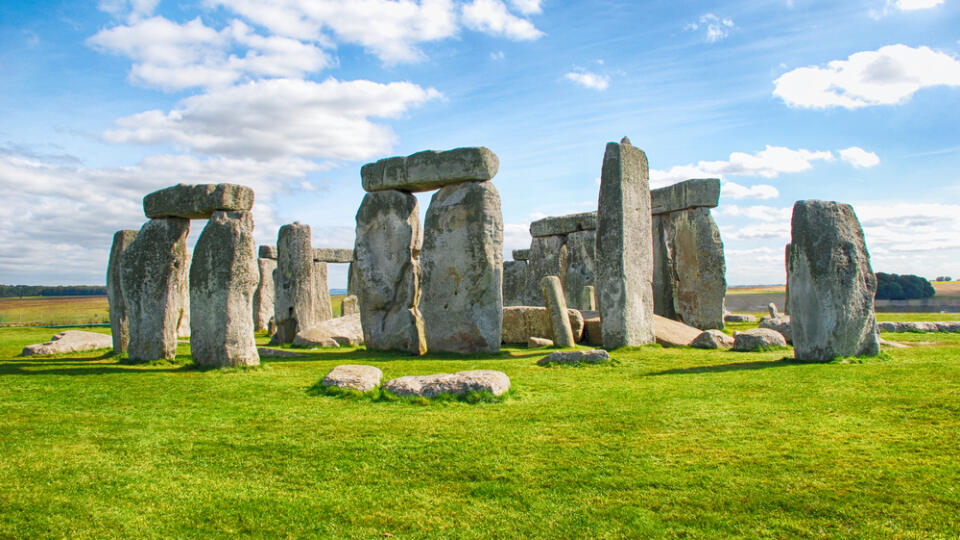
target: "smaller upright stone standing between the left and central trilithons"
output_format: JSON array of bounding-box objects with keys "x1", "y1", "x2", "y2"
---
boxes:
[{"x1": 273, "y1": 223, "x2": 319, "y2": 343}]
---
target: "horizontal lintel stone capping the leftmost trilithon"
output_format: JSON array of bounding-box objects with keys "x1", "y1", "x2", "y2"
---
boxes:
[{"x1": 143, "y1": 184, "x2": 253, "y2": 219}]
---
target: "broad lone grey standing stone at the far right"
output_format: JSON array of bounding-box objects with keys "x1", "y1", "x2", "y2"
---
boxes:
[{"x1": 787, "y1": 201, "x2": 880, "y2": 361}]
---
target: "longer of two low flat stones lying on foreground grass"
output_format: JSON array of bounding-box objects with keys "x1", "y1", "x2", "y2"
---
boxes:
[{"x1": 383, "y1": 369, "x2": 510, "y2": 398}]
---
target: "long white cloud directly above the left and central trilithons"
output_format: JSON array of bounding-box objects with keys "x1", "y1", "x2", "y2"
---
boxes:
[{"x1": 105, "y1": 78, "x2": 441, "y2": 160}]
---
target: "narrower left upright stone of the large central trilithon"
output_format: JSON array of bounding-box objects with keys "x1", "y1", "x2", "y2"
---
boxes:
[{"x1": 353, "y1": 191, "x2": 427, "y2": 354}]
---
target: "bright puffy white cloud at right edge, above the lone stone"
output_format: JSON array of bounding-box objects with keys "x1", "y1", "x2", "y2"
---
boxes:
[{"x1": 773, "y1": 45, "x2": 960, "y2": 109}]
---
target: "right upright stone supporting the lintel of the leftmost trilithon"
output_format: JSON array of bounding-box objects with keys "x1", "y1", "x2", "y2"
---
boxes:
[{"x1": 190, "y1": 211, "x2": 260, "y2": 367}]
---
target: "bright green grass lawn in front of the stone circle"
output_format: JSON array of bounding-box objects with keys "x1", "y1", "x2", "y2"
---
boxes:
[{"x1": 0, "y1": 322, "x2": 960, "y2": 538}]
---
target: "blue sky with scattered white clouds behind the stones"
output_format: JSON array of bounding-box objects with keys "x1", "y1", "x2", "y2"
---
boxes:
[{"x1": 0, "y1": 0, "x2": 960, "y2": 288}]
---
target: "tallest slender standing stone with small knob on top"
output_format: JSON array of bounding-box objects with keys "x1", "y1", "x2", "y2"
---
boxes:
[{"x1": 596, "y1": 137, "x2": 655, "y2": 349}]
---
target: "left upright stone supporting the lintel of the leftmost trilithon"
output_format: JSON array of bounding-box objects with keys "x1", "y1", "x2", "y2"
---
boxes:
[{"x1": 120, "y1": 218, "x2": 190, "y2": 362}]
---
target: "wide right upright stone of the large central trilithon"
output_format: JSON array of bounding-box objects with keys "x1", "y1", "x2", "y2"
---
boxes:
[{"x1": 424, "y1": 182, "x2": 503, "y2": 353}]
